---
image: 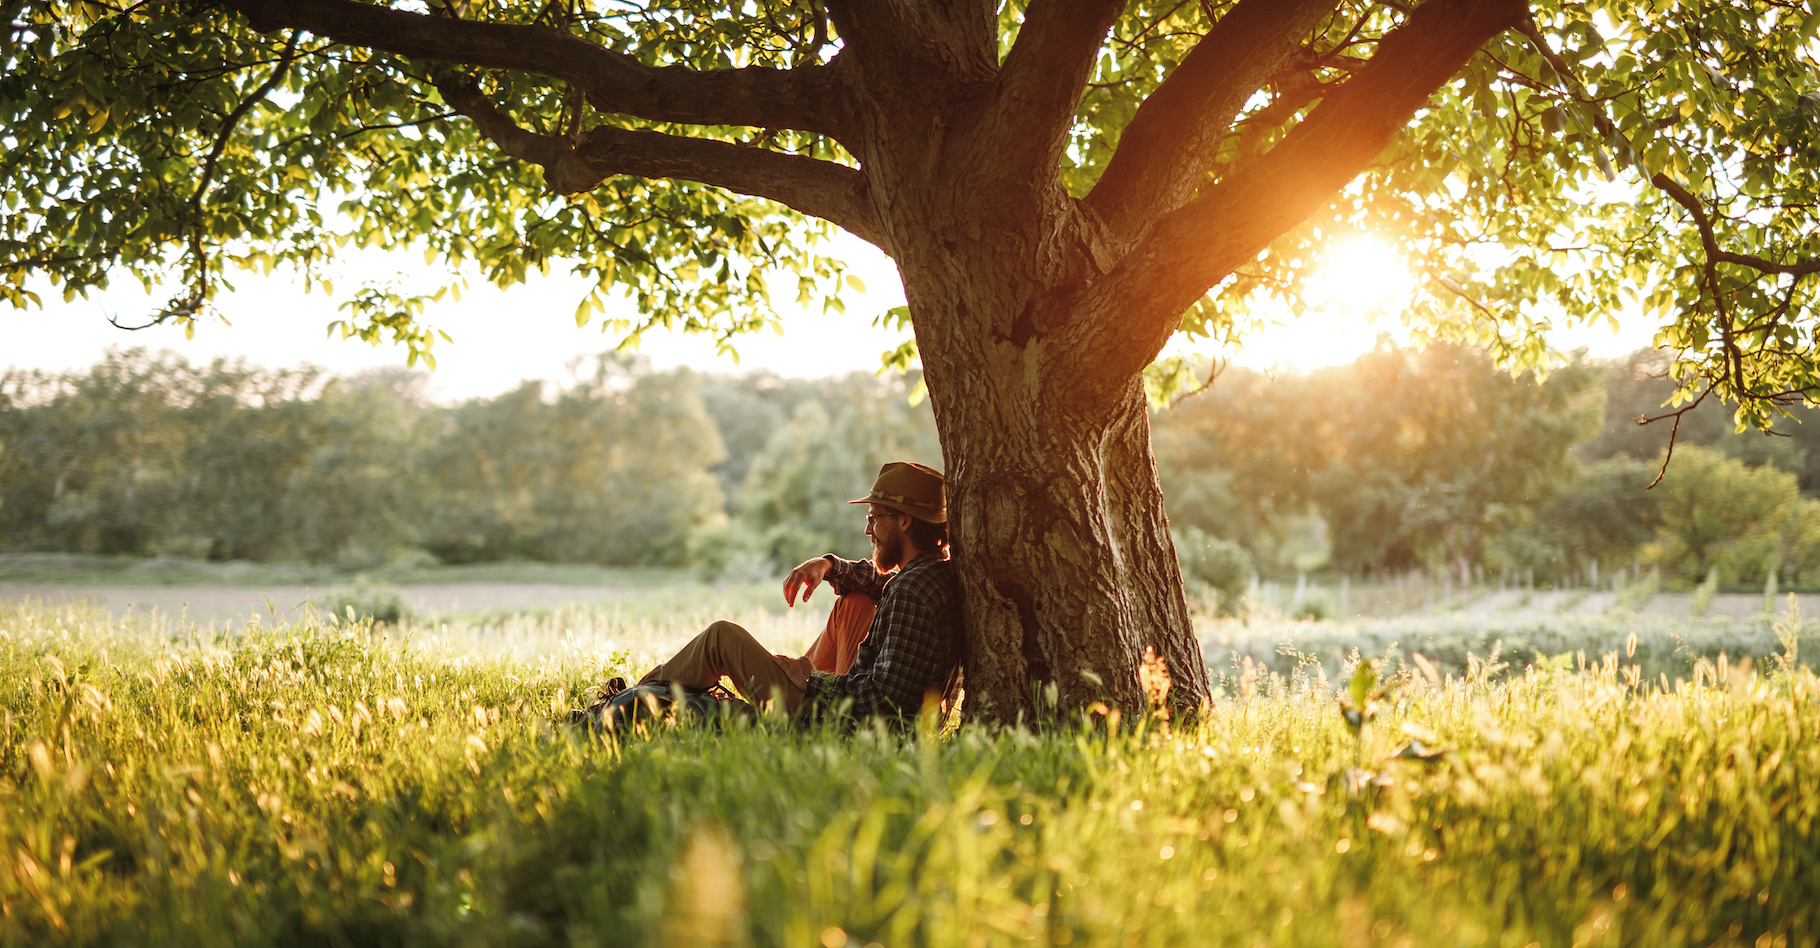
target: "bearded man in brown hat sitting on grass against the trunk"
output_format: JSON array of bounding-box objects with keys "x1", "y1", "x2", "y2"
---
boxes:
[{"x1": 618, "y1": 460, "x2": 965, "y2": 717}]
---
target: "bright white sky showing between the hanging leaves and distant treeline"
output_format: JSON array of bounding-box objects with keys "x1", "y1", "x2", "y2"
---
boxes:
[{"x1": 0, "y1": 237, "x2": 1654, "y2": 400}]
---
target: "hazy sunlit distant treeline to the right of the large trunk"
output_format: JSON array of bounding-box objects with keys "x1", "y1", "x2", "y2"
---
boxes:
[{"x1": 1154, "y1": 346, "x2": 1820, "y2": 604}]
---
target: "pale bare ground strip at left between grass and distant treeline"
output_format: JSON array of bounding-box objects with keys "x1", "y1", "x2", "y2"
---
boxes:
[{"x1": 0, "y1": 582, "x2": 626, "y2": 626}]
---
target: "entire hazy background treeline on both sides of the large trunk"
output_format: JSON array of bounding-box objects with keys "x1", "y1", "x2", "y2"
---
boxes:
[{"x1": 0, "y1": 346, "x2": 1820, "y2": 591}]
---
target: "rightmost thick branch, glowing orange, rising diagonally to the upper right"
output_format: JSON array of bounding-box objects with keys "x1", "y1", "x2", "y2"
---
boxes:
[{"x1": 1056, "y1": 0, "x2": 1527, "y2": 404}]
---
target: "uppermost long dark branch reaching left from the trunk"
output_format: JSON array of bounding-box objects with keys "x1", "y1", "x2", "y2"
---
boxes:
[{"x1": 218, "y1": 0, "x2": 843, "y2": 138}]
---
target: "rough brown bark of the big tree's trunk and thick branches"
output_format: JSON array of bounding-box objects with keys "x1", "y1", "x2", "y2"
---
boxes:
[{"x1": 228, "y1": 0, "x2": 1527, "y2": 721}]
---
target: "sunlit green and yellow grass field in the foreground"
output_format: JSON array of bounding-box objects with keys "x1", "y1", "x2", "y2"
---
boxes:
[{"x1": 0, "y1": 600, "x2": 1820, "y2": 948}]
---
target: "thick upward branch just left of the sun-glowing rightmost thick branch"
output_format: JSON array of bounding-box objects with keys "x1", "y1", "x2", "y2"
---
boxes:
[{"x1": 1087, "y1": 0, "x2": 1336, "y2": 238}]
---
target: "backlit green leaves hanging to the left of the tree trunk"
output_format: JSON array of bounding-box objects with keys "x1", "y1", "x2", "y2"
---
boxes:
[{"x1": 0, "y1": 0, "x2": 839, "y2": 364}]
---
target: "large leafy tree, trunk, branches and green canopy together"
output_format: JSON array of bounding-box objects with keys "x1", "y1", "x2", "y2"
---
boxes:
[{"x1": 0, "y1": 0, "x2": 1820, "y2": 717}]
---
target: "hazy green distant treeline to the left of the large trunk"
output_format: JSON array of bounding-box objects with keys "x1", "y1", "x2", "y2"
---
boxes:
[{"x1": 0, "y1": 349, "x2": 941, "y2": 573}]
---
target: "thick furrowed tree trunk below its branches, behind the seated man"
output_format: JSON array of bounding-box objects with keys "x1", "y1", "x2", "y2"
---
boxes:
[{"x1": 901, "y1": 221, "x2": 1208, "y2": 721}]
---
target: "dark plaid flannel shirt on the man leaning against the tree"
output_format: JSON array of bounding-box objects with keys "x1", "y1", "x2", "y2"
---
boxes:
[{"x1": 804, "y1": 553, "x2": 961, "y2": 715}]
